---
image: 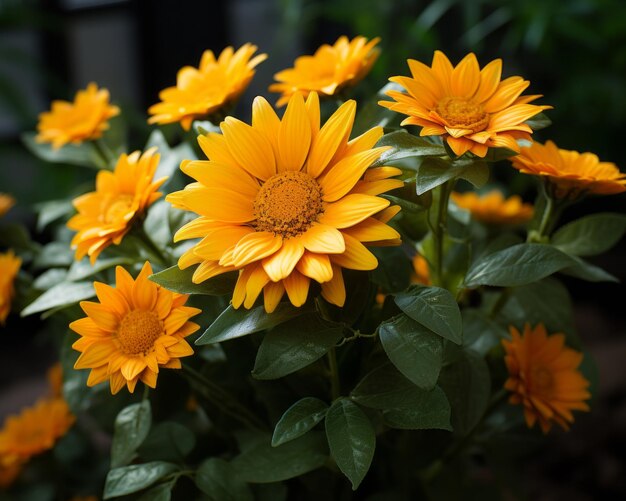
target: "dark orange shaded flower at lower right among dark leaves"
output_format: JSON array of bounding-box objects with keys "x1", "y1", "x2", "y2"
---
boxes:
[{"x1": 502, "y1": 324, "x2": 591, "y2": 433}]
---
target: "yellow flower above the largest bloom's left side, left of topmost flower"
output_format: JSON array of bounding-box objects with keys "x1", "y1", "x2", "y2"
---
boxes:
[{"x1": 148, "y1": 43, "x2": 267, "y2": 130}]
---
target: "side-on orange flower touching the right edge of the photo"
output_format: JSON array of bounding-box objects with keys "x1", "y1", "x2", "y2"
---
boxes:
[{"x1": 512, "y1": 141, "x2": 626, "y2": 198}]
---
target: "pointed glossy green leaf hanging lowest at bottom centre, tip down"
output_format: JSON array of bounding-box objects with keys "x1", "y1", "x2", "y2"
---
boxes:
[{"x1": 326, "y1": 398, "x2": 376, "y2": 490}]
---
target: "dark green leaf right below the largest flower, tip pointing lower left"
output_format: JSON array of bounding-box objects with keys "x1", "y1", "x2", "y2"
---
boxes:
[{"x1": 252, "y1": 313, "x2": 343, "y2": 379}]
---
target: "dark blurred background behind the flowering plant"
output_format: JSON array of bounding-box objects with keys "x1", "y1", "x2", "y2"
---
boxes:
[{"x1": 0, "y1": 0, "x2": 626, "y2": 500}]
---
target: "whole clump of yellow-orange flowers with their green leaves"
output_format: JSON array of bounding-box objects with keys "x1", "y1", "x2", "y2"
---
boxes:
[{"x1": 0, "y1": 37, "x2": 626, "y2": 501}]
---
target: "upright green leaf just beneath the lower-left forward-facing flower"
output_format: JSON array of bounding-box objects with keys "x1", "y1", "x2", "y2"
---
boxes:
[{"x1": 111, "y1": 400, "x2": 152, "y2": 468}]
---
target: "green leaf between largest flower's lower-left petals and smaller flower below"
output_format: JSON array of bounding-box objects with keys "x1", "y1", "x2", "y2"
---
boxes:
[{"x1": 148, "y1": 265, "x2": 237, "y2": 296}]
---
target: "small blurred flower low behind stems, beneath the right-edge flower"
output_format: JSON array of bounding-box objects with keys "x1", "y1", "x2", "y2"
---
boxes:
[{"x1": 450, "y1": 190, "x2": 533, "y2": 225}]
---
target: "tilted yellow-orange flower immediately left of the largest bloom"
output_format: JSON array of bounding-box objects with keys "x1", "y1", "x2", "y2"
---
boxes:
[{"x1": 67, "y1": 148, "x2": 167, "y2": 264}]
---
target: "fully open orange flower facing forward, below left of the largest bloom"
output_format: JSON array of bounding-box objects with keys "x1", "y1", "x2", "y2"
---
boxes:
[{"x1": 70, "y1": 262, "x2": 201, "y2": 394}]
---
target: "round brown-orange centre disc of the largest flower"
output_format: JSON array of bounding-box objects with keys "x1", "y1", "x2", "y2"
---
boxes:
[{"x1": 254, "y1": 171, "x2": 324, "y2": 238}]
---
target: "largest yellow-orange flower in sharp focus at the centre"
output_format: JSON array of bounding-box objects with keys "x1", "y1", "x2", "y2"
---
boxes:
[{"x1": 166, "y1": 92, "x2": 402, "y2": 312}]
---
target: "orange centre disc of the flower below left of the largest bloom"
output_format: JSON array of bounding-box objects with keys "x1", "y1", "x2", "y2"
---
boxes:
[{"x1": 117, "y1": 310, "x2": 163, "y2": 355}]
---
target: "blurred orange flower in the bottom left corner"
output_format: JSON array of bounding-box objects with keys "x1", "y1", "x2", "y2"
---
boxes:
[{"x1": 0, "y1": 398, "x2": 75, "y2": 468}]
